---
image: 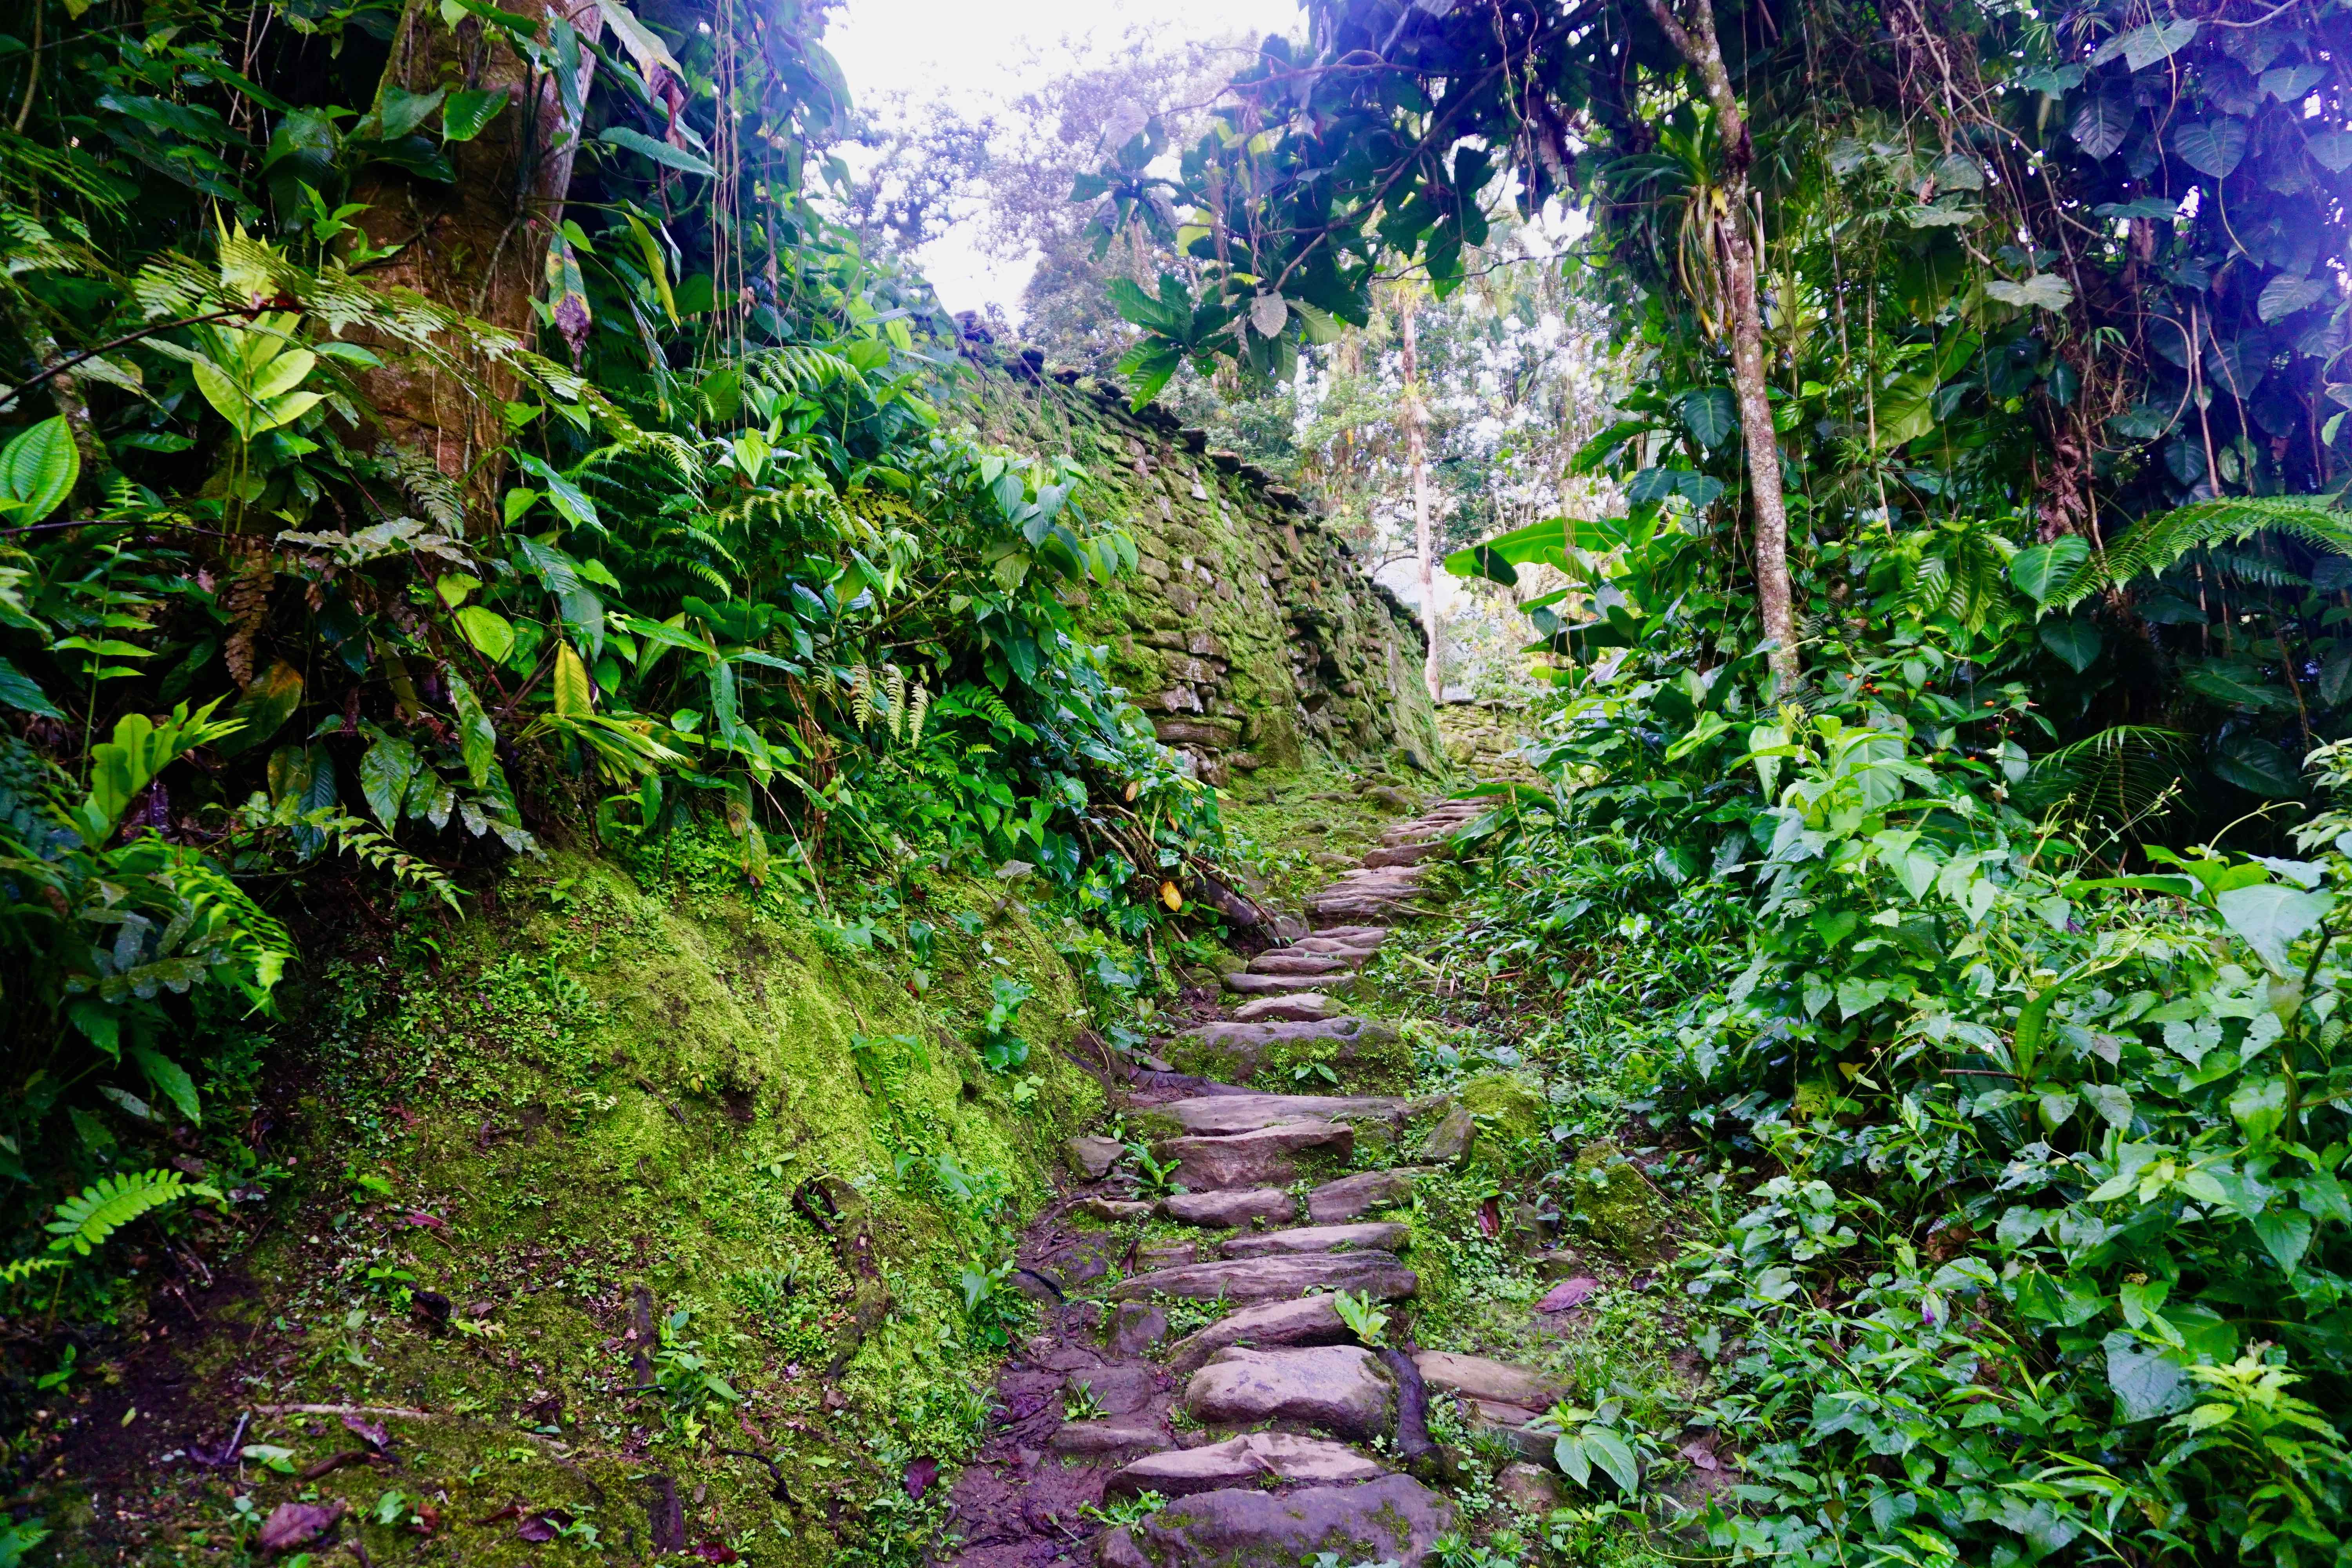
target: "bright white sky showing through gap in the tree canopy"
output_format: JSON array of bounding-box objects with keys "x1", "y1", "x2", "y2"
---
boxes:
[{"x1": 826, "y1": 0, "x2": 1298, "y2": 320}]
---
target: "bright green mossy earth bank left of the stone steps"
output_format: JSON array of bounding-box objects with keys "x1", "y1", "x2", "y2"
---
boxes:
[{"x1": 27, "y1": 842, "x2": 1129, "y2": 1566}]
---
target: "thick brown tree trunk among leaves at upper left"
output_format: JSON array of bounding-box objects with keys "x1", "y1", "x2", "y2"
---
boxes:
[{"x1": 350, "y1": 0, "x2": 604, "y2": 522}]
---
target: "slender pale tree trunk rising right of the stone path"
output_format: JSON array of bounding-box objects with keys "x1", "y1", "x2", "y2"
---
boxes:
[{"x1": 1649, "y1": 0, "x2": 1802, "y2": 693}]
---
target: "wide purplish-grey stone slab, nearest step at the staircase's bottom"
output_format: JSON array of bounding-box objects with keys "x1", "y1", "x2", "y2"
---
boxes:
[{"x1": 1096, "y1": 1476, "x2": 1454, "y2": 1568}]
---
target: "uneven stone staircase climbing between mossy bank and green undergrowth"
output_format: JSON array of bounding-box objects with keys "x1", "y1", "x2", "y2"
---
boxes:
[{"x1": 950, "y1": 802, "x2": 1559, "y2": 1568}]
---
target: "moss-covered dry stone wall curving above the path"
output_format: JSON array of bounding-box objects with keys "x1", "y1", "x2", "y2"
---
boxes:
[{"x1": 964, "y1": 341, "x2": 1444, "y2": 783}]
